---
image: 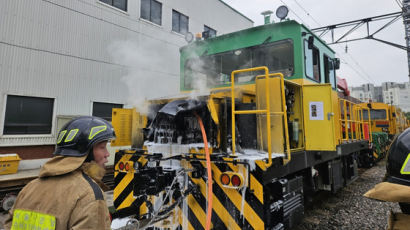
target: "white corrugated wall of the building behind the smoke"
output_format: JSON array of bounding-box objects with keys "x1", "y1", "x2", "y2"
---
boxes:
[{"x1": 0, "y1": 0, "x2": 253, "y2": 146}]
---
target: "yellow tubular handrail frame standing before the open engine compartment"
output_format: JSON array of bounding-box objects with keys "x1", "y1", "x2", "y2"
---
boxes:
[{"x1": 231, "y1": 66, "x2": 290, "y2": 168}]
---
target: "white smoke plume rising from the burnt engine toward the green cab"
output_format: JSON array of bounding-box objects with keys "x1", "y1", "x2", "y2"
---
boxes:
[{"x1": 108, "y1": 39, "x2": 218, "y2": 114}]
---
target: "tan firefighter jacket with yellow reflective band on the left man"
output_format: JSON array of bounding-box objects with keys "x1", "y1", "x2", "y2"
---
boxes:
[{"x1": 5, "y1": 156, "x2": 111, "y2": 230}]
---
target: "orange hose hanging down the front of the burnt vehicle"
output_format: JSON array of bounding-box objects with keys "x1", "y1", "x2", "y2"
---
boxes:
[{"x1": 194, "y1": 112, "x2": 213, "y2": 230}]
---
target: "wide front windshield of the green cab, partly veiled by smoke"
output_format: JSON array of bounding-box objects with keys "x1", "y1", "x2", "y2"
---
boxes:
[{"x1": 184, "y1": 40, "x2": 294, "y2": 89}]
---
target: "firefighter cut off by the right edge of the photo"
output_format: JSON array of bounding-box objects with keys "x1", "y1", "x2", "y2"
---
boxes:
[{"x1": 364, "y1": 129, "x2": 410, "y2": 230}]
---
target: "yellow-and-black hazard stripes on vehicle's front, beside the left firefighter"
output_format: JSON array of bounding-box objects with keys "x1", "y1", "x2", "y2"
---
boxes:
[{"x1": 113, "y1": 151, "x2": 146, "y2": 217}]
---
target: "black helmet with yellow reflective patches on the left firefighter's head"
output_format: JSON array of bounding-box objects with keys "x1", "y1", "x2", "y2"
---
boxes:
[{"x1": 54, "y1": 116, "x2": 115, "y2": 157}]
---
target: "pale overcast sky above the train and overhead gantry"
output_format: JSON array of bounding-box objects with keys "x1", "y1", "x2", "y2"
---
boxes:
[{"x1": 223, "y1": 0, "x2": 409, "y2": 86}]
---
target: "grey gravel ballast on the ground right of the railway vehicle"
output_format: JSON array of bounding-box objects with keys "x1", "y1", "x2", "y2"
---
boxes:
[{"x1": 295, "y1": 161, "x2": 400, "y2": 230}]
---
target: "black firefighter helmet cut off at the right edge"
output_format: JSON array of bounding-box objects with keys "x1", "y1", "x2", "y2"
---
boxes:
[{"x1": 386, "y1": 128, "x2": 410, "y2": 186}]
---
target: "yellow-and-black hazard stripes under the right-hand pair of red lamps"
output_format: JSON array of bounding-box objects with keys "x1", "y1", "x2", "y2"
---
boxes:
[{"x1": 188, "y1": 164, "x2": 264, "y2": 230}]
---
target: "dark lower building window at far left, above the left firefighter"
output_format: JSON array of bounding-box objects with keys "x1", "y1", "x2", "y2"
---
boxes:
[{"x1": 3, "y1": 95, "x2": 54, "y2": 135}]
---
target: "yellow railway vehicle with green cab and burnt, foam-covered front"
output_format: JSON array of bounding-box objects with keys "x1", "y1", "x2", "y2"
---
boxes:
[{"x1": 112, "y1": 21, "x2": 371, "y2": 229}]
